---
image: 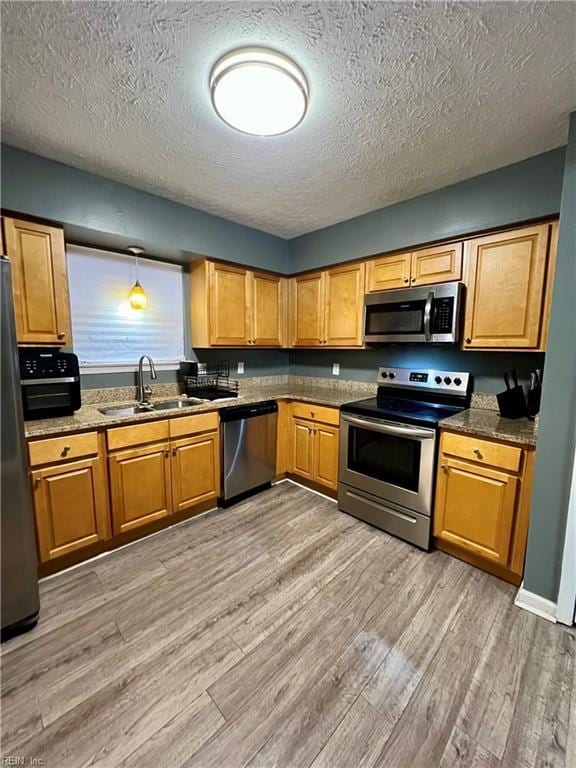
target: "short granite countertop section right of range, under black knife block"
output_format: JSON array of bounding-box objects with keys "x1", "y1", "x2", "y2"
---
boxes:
[{"x1": 441, "y1": 408, "x2": 538, "y2": 447}]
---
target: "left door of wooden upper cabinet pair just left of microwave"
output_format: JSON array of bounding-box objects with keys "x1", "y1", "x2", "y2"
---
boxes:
[{"x1": 291, "y1": 272, "x2": 325, "y2": 347}]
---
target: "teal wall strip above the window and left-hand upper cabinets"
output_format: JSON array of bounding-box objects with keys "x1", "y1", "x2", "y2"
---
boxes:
[{"x1": 0, "y1": 145, "x2": 289, "y2": 272}]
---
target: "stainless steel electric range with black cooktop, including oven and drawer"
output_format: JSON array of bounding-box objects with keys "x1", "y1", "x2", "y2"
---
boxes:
[{"x1": 338, "y1": 367, "x2": 471, "y2": 549}]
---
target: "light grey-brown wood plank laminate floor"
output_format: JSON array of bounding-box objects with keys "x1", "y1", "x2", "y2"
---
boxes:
[{"x1": 2, "y1": 483, "x2": 576, "y2": 768}]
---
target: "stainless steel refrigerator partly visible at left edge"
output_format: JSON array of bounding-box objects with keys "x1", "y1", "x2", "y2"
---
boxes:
[{"x1": 0, "y1": 256, "x2": 40, "y2": 639}]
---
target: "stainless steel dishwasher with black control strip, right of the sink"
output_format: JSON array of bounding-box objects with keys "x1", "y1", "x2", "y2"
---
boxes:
[{"x1": 220, "y1": 400, "x2": 278, "y2": 506}]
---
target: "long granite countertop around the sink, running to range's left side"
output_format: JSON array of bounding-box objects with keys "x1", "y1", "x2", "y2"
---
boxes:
[{"x1": 24, "y1": 384, "x2": 370, "y2": 437}]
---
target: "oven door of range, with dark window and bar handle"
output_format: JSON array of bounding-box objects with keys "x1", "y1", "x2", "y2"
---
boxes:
[{"x1": 339, "y1": 413, "x2": 436, "y2": 515}]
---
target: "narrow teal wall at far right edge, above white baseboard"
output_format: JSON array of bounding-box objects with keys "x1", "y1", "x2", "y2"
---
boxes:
[{"x1": 524, "y1": 117, "x2": 576, "y2": 601}]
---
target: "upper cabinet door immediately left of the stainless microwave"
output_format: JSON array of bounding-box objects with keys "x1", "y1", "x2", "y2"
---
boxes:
[{"x1": 324, "y1": 264, "x2": 364, "y2": 347}]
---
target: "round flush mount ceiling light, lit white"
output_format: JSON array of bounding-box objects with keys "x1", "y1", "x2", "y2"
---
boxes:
[{"x1": 210, "y1": 48, "x2": 308, "y2": 136}]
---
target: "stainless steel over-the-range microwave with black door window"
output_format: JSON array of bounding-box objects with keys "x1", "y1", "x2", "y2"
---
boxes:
[{"x1": 364, "y1": 283, "x2": 464, "y2": 344}]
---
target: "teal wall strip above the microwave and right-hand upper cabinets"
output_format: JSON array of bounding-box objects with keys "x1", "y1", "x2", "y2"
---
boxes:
[{"x1": 290, "y1": 147, "x2": 565, "y2": 272}]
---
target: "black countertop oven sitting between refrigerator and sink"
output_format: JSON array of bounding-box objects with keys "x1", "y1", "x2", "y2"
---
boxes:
[{"x1": 18, "y1": 347, "x2": 81, "y2": 420}]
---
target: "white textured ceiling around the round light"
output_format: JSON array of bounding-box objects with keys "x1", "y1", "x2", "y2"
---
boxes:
[{"x1": 1, "y1": 0, "x2": 576, "y2": 237}]
